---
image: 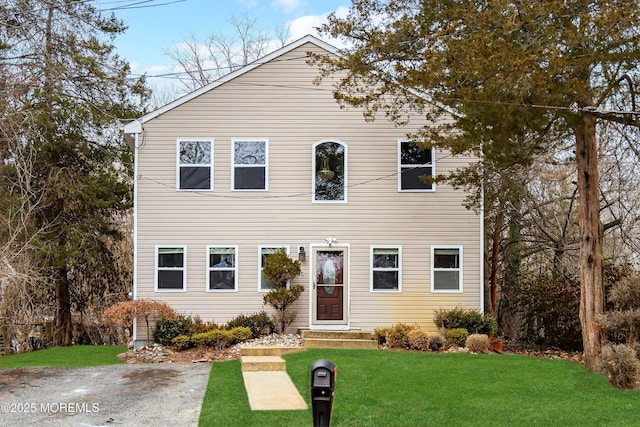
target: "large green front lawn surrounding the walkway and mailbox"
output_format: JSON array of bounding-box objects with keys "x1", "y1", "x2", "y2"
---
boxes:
[{"x1": 200, "y1": 349, "x2": 640, "y2": 427}]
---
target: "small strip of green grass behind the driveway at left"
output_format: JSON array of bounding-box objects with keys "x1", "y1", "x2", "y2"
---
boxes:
[{"x1": 0, "y1": 345, "x2": 127, "y2": 368}]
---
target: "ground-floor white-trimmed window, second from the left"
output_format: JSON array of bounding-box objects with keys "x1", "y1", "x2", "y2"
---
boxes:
[{"x1": 207, "y1": 246, "x2": 238, "y2": 292}]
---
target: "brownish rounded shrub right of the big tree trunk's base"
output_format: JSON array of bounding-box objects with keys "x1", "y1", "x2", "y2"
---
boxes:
[{"x1": 601, "y1": 344, "x2": 639, "y2": 389}]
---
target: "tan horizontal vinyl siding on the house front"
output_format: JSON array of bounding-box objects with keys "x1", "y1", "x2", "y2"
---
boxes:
[{"x1": 131, "y1": 44, "x2": 481, "y2": 342}]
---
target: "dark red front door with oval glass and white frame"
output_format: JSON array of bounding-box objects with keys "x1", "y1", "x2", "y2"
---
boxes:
[{"x1": 313, "y1": 247, "x2": 348, "y2": 325}]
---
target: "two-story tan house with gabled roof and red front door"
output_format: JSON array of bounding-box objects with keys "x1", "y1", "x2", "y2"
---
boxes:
[{"x1": 124, "y1": 36, "x2": 483, "y2": 346}]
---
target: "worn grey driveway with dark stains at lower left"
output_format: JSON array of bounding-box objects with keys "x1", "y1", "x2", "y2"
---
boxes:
[{"x1": 0, "y1": 363, "x2": 211, "y2": 427}]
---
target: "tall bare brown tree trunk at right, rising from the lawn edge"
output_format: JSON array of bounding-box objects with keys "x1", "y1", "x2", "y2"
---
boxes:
[{"x1": 574, "y1": 113, "x2": 606, "y2": 371}]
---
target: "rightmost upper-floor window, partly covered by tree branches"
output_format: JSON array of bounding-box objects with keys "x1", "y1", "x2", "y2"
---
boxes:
[{"x1": 398, "y1": 141, "x2": 434, "y2": 191}]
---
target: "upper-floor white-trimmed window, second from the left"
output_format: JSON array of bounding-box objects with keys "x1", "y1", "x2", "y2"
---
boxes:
[{"x1": 231, "y1": 139, "x2": 268, "y2": 191}]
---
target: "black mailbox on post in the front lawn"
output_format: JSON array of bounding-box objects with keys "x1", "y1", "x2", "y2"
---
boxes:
[{"x1": 311, "y1": 359, "x2": 336, "y2": 427}]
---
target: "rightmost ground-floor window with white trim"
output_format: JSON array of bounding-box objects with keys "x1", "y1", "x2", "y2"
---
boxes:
[{"x1": 431, "y1": 246, "x2": 462, "y2": 292}]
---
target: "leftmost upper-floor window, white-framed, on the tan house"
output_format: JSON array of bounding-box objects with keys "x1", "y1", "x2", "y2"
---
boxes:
[{"x1": 177, "y1": 139, "x2": 213, "y2": 190}]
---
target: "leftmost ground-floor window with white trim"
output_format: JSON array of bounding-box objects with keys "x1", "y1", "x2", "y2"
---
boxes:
[{"x1": 155, "y1": 246, "x2": 187, "y2": 292}]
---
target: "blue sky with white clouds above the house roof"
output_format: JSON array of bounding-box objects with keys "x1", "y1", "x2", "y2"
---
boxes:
[{"x1": 96, "y1": 0, "x2": 350, "y2": 80}]
